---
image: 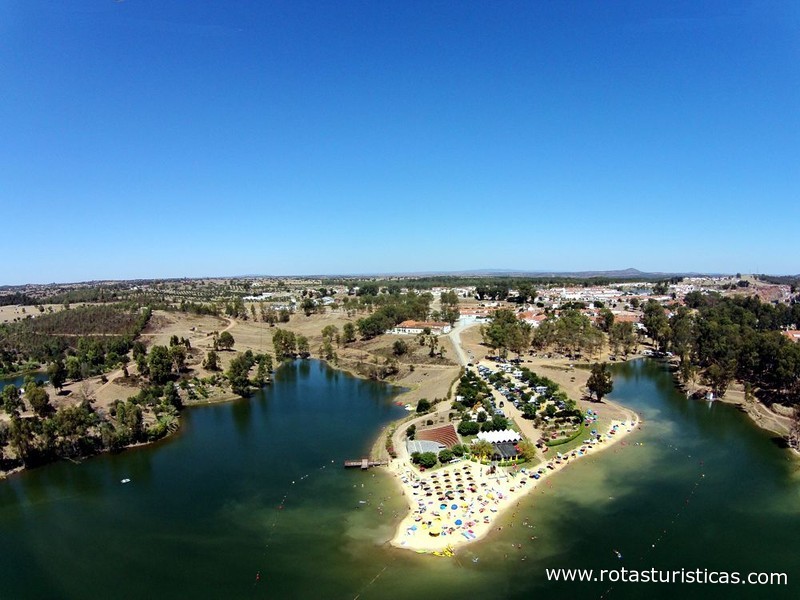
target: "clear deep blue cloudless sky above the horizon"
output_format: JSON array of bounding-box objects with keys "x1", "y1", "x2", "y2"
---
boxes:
[{"x1": 0, "y1": 0, "x2": 800, "y2": 284}]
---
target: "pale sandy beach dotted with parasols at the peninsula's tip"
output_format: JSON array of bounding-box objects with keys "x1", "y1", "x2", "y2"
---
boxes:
[{"x1": 387, "y1": 412, "x2": 640, "y2": 555}]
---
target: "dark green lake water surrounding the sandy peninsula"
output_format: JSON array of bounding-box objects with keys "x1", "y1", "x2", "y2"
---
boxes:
[{"x1": 0, "y1": 361, "x2": 800, "y2": 599}]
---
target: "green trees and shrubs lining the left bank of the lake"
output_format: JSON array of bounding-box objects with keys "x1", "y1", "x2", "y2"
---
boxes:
[{"x1": 0, "y1": 324, "x2": 273, "y2": 471}]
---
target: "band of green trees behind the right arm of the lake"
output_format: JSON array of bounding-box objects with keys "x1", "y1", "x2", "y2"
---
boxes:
[{"x1": 481, "y1": 292, "x2": 800, "y2": 406}]
